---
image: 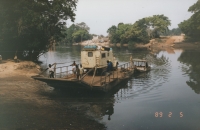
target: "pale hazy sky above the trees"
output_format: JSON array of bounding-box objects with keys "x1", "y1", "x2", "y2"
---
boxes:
[{"x1": 67, "y1": 0, "x2": 197, "y2": 35}]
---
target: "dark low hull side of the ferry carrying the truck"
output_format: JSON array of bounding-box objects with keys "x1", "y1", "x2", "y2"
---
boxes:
[{"x1": 32, "y1": 70, "x2": 134, "y2": 92}]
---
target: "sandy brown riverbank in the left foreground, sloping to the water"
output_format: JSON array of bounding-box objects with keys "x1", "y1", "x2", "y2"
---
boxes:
[{"x1": 0, "y1": 60, "x2": 105, "y2": 130}]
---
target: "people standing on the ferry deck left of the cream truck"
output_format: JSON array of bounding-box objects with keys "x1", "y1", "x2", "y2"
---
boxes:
[{"x1": 48, "y1": 61, "x2": 84, "y2": 79}]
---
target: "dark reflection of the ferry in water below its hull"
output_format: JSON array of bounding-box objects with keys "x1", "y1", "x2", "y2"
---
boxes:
[{"x1": 45, "y1": 88, "x2": 115, "y2": 120}]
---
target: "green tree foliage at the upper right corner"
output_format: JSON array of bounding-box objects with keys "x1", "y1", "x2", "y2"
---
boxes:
[{"x1": 179, "y1": 0, "x2": 200, "y2": 41}]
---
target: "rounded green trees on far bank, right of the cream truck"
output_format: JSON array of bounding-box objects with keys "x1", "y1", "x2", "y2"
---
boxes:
[{"x1": 107, "y1": 15, "x2": 171, "y2": 45}]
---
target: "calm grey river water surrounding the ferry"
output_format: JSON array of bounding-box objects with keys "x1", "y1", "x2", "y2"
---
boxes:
[{"x1": 40, "y1": 46, "x2": 200, "y2": 130}]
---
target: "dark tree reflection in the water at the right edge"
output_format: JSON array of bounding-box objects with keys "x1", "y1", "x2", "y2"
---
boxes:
[{"x1": 178, "y1": 50, "x2": 200, "y2": 94}]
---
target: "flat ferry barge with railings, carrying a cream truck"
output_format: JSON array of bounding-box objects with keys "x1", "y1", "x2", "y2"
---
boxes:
[{"x1": 32, "y1": 45, "x2": 134, "y2": 92}]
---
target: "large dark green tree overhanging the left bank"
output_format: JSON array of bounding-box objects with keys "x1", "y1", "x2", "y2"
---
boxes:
[{"x1": 0, "y1": 0, "x2": 77, "y2": 60}]
